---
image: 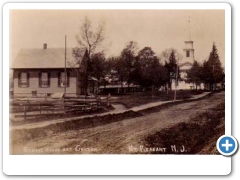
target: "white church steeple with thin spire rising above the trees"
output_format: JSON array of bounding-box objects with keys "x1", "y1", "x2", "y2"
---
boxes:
[{"x1": 183, "y1": 19, "x2": 194, "y2": 63}]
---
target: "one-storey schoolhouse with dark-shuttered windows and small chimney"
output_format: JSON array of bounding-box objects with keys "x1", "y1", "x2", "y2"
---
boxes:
[{"x1": 11, "y1": 44, "x2": 96, "y2": 96}]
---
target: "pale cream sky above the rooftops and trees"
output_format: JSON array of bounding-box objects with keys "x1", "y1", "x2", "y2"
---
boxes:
[{"x1": 10, "y1": 10, "x2": 225, "y2": 66}]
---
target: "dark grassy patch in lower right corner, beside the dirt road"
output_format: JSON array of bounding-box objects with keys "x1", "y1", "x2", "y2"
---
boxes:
[{"x1": 144, "y1": 103, "x2": 225, "y2": 154}]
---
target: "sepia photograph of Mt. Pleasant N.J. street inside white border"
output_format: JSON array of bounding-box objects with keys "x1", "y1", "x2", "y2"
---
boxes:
[{"x1": 9, "y1": 9, "x2": 226, "y2": 155}]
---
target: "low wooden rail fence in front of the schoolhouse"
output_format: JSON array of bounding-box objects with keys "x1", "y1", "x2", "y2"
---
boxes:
[{"x1": 10, "y1": 97, "x2": 101, "y2": 120}]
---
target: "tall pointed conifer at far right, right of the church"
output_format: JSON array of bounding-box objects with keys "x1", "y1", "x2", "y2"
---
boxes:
[{"x1": 202, "y1": 43, "x2": 224, "y2": 90}]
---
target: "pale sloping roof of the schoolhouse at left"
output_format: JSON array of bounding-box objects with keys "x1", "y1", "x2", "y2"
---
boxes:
[{"x1": 11, "y1": 48, "x2": 79, "y2": 69}]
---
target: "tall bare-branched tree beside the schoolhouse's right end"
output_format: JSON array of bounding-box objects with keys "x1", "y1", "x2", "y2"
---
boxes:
[{"x1": 73, "y1": 17, "x2": 104, "y2": 95}]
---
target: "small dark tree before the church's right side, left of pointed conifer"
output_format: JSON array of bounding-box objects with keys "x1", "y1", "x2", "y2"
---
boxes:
[{"x1": 187, "y1": 61, "x2": 202, "y2": 89}]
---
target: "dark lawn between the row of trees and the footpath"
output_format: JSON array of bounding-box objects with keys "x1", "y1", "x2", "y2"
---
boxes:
[{"x1": 111, "y1": 90, "x2": 203, "y2": 108}]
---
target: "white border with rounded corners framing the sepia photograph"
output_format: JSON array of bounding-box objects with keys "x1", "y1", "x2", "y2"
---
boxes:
[{"x1": 3, "y1": 3, "x2": 231, "y2": 175}]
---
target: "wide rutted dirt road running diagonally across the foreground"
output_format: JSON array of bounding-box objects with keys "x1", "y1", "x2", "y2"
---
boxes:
[{"x1": 11, "y1": 92, "x2": 225, "y2": 154}]
